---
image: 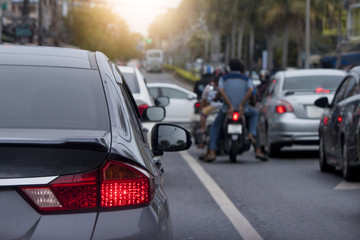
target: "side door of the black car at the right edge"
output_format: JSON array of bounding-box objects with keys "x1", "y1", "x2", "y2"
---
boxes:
[{"x1": 323, "y1": 77, "x2": 352, "y2": 160}]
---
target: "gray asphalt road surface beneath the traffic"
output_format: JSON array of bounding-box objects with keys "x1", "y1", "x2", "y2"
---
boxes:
[{"x1": 145, "y1": 70, "x2": 360, "y2": 240}]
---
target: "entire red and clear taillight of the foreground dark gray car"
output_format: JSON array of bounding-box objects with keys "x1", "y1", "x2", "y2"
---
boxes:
[{"x1": 20, "y1": 160, "x2": 154, "y2": 213}]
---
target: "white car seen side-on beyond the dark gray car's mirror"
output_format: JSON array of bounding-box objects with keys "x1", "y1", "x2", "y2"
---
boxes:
[{"x1": 147, "y1": 83, "x2": 197, "y2": 123}]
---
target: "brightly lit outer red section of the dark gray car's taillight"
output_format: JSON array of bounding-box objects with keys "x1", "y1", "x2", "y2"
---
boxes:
[{"x1": 100, "y1": 162, "x2": 152, "y2": 207}]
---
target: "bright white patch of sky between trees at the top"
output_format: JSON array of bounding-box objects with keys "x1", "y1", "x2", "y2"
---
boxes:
[{"x1": 108, "y1": 0, "x2": 181, "y2": 36}]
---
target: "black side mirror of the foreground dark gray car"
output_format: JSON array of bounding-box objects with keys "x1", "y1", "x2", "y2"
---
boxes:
[{"x1": 151, "y1": 123, "x2": 192, "y2": 153}]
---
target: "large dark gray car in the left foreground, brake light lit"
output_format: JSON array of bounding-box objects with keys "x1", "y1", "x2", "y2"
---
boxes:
[{"x1": 0, "y1": 46, "x2": 191, "y2": 239}]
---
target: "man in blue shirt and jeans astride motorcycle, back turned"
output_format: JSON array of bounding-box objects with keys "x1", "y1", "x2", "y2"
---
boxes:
[{"x1": 201, "y1": 59, "x2": 267, "y2": 162}]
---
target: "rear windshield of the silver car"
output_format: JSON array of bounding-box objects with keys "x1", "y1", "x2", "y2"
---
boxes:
[{"x1": 284, "y1": 76, "x2": 344, "y2": 91}]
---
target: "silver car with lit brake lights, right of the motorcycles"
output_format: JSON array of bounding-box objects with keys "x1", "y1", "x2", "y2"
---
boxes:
[{"x1": 258, "y1": 69, "x2": 346, "y2": 156}]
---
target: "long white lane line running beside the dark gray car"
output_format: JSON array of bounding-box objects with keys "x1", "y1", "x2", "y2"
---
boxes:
[{"x1": 180, "y1": 151, "x2": 263, "y2": 240}]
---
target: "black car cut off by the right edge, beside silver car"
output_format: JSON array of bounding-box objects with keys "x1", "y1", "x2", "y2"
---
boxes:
[{"x1": 315, "y1": 66, "x2": 360, "y2": 181}]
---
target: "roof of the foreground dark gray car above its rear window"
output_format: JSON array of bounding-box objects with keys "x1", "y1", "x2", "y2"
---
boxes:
[{"x1": 0, "y1": 45, "x2": 97, "y2": 69}]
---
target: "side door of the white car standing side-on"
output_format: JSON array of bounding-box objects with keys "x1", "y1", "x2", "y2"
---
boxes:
[{"x1": 160, "y1": 87, "x2": 195, "y2": 122}]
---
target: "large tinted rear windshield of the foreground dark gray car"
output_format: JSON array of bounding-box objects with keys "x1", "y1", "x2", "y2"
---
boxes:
[{"x1": 0, "y1": 66, "x2": 109, "y2": 130}]
